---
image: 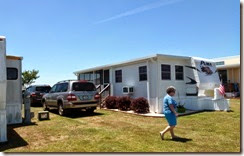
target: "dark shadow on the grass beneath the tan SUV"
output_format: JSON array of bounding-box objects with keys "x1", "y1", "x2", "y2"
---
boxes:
[{"x1": 49, "y1": 109, "x2": 104, "y2": 118}]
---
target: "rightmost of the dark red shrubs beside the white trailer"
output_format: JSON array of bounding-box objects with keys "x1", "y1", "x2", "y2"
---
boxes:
[{"x1": 131, "y1": 97, "x2": 149, "y2": 113}]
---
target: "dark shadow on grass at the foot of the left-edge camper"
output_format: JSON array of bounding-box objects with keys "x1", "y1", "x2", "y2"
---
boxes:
[{"x1": 0, "y1": 123, "x2": 36, "y2": 152}]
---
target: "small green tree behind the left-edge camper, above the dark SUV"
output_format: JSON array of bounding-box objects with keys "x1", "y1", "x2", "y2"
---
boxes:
[{"x1": 22, "y1": 69, "x2": 40, "y2": 86}]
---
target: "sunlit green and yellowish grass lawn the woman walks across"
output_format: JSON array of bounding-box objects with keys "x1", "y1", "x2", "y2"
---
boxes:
[{"x1": 0, "y1": 100, "x2": 240, "y2": 152}]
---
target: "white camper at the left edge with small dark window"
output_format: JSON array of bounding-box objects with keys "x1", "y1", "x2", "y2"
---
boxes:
[{"x1": 0, "y1": 36, "x2": 22, "y2": 142}]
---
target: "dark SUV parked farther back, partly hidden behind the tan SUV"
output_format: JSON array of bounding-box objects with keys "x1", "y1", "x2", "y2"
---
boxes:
[{"x1": 23, "y1": 85, "x2": 51, "y2": 105}]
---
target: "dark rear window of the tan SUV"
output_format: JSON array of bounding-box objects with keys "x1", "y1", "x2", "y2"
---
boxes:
[{"x1": 72, "y1": 82, "x2": 96, "y2": 91}]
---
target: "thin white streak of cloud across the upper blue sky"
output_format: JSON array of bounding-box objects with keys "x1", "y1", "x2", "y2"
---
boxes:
[{"x1": 96, "y1": 0, "x2": 182, "y2": 24}]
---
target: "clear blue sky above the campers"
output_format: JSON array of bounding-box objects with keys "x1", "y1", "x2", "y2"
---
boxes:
[{"x1": 0, "y1": 0, "x2": 240, "y2": 85}]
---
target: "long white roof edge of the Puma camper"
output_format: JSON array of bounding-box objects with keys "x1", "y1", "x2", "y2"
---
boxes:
[{"x1": 74, "y1": 54, "x2": 191, "y2": 75}]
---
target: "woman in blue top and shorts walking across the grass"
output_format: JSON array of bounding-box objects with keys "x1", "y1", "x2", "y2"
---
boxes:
[{"x1": 160, "y1": 86, "x2": 178, "y2": 140}]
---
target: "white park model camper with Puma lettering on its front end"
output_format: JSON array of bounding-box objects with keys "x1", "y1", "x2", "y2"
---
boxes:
[{"x1": 74, "y1": 54, "x2": 229, "y2": 113}]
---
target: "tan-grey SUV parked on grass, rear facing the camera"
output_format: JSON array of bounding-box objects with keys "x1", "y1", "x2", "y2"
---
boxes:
[{"x1": 42, "y1": 80, "x2": 100, "y2": 116}]
